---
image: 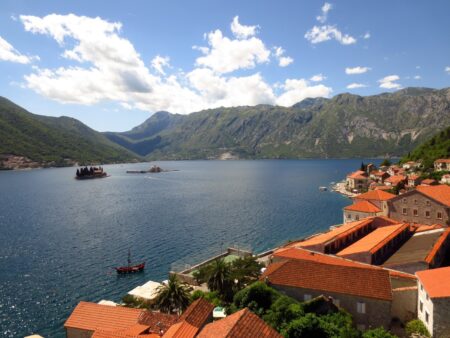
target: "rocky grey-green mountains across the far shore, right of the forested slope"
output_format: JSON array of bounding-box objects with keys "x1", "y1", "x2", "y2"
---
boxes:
[{"x1": 105, "y1": 88, "x2": 450, "y2": 159}]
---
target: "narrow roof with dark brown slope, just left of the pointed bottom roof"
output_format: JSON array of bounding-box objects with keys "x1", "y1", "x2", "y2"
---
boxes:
[{"x1": 163, "y1": 298, "x2": 214, "y2": 338}]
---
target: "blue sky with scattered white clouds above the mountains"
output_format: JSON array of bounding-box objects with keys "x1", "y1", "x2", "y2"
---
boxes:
[{"x1": 0, "y1": 0, "x2": 450, "y2": 131}]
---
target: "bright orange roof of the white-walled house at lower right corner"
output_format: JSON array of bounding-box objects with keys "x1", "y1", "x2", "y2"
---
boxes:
[{"x1": 416, "y1": 267, "x2": 450, "y2": 298}]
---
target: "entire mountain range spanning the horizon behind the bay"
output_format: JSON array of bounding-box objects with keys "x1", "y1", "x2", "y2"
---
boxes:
[{"x1": 0, "y1": 88, "x2": 450, "y2": 165}]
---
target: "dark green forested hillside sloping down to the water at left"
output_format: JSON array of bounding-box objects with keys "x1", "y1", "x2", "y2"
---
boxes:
[{"x1": 0, "y1": 97, "x2": 138, "y2": 165}]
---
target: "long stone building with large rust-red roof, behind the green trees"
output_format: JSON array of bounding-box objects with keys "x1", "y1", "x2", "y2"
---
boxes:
[{"x1": 261, "y1": 248, "x2": 416, "y2": 330}]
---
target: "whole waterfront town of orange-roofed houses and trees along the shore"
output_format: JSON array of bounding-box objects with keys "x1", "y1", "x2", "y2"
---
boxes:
[{"x1": 26, "y1": 159, "x2": 450, "y2": 338}]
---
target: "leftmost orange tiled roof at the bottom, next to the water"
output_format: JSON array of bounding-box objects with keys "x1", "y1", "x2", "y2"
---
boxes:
[{"x1": 64, "y1": 302, "x2": 142, "y2": 331}]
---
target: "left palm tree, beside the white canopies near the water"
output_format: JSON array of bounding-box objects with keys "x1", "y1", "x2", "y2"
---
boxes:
[{"x1": 155, "y1": 275, "x2": 192, "y2": 314}]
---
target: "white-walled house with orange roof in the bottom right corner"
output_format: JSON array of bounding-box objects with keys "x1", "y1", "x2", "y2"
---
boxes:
[{"x1": 416, "y1": 267, "x2": 450, "y2": 338}]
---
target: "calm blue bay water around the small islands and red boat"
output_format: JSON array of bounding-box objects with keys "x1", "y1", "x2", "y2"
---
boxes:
[{"x1": 0, "y1": 160, "x2": 374, "y2": 337}]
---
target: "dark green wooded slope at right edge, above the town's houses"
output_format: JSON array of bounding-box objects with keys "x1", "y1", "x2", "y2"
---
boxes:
[{"x1": 401, "y1": 126, "x2": 450, "y2": 168}]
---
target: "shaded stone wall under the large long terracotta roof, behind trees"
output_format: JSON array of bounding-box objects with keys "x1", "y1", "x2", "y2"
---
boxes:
[{"x1": 270, "y1": 284, "x2": 391, "y2": 329}]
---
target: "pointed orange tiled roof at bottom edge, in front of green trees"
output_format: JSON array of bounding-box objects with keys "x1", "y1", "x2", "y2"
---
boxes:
[{"x1": 197, "y1": 308, "x2": 282, "y2": 338}]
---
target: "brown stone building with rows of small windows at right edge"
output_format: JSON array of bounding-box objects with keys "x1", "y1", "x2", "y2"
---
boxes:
[{"x1": 388, "y1": 185, "x2": 450, "y2": 226}]
